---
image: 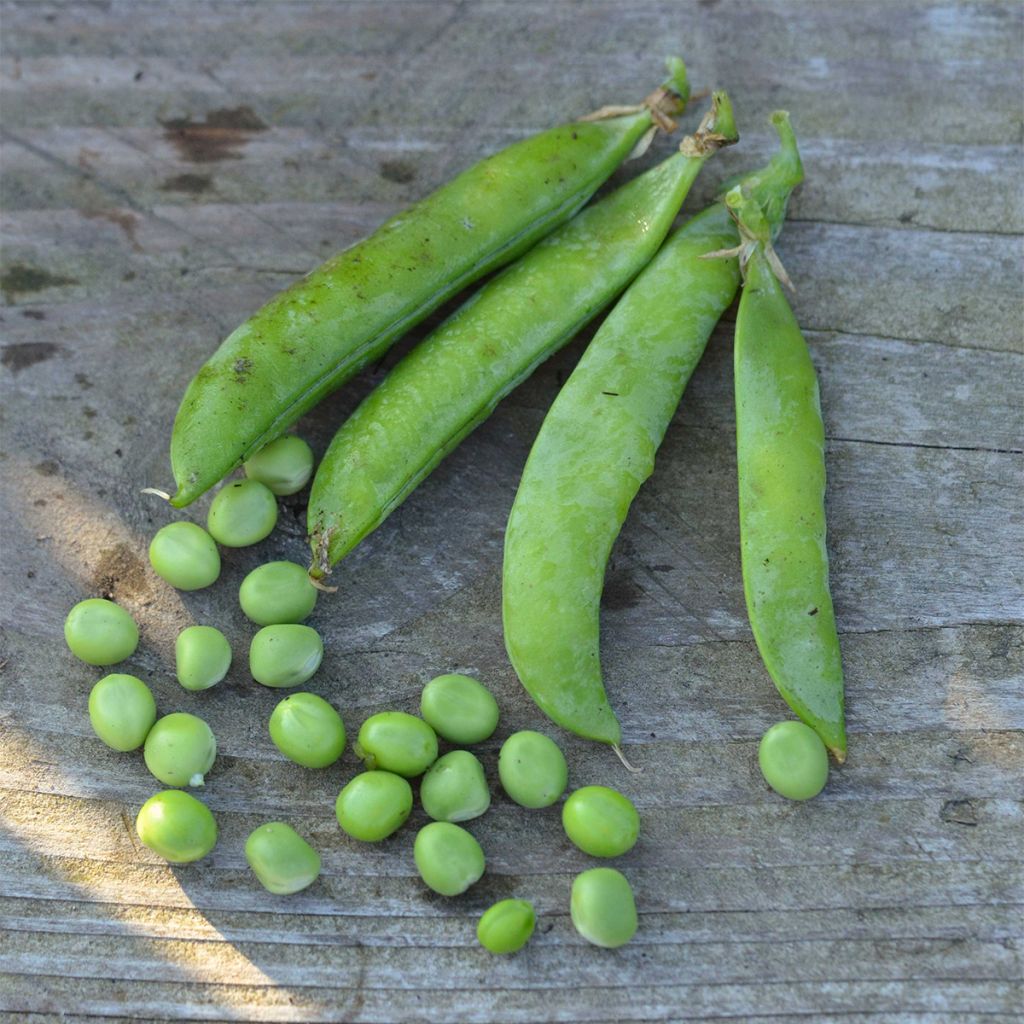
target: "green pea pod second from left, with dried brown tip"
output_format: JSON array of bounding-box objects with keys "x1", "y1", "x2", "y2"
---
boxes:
[{"x1": 308, "y1": 92, "x2": 736, "y2": 578}]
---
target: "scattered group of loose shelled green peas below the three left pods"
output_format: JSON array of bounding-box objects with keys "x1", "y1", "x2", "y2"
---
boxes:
[{"x1": 65, "y1": 435, "x2": 651, "y2": 953}]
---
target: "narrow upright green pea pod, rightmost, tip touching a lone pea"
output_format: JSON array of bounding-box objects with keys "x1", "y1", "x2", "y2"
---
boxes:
[{"x1": 727, "y1": 187, "x2": 846, "y2": 761}]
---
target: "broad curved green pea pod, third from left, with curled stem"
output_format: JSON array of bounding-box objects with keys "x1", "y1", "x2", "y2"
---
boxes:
[{"x1": 502, "y1": 112, "x2": 803, "y2": 743}]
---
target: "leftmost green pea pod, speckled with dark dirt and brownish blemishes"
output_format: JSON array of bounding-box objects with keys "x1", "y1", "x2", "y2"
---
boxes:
[{"x1": 171, "y1": 58, "x2": 689, "y2": 508}]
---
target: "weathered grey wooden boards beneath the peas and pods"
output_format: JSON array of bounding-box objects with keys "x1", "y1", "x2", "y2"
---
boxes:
[{"x1": 0, "y1": 0, "x2": 1024, "y2": 1024}]
